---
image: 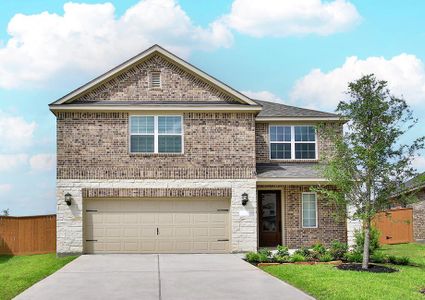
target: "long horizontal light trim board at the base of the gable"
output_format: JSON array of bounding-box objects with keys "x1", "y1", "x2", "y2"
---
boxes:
[{"x1": 49, "y1": 104, "x2": 261, "y2": 112}]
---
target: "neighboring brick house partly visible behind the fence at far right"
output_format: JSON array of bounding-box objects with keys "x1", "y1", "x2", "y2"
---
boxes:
[{"x1": 393, "y1": 173, "x2": 425, "y2": 241}]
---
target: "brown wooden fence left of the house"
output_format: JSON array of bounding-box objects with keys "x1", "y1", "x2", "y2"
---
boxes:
[{"x1": 0, "y1": 215, "x2": 56, "y2": 255}]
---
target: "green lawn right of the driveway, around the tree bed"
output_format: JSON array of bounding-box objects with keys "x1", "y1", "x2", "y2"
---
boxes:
[{"x1": 262, "y1": 244, "x2": 425, "y2": 300}]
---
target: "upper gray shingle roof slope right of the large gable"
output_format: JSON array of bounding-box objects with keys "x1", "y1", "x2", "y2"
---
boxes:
[{"x1": 253, "y1": 99, "x2": 339, "y2": 118}]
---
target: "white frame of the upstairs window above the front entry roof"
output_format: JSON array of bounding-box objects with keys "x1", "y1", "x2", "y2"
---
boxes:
[{"x1": 268, "y1": 124, "x2": 319, "y2": 161}]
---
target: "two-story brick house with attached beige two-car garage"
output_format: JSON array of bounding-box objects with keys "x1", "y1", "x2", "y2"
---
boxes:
[{"x1": 49, "y1": 45, "x2": 347, "y2": 254}]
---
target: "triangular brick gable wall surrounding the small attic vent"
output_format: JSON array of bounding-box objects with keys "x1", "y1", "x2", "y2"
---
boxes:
[{"x1": 74, "y1": 54, "x2": 241, "y2": 104}]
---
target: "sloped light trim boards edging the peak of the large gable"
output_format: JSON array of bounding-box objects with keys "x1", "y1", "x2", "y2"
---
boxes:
[{"x1": 52, "y1": 45, "x2": 258, "y2": 106}]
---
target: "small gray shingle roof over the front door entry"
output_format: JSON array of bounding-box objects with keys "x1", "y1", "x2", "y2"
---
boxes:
[{"x1": 257, "y1": 163, "x2": 323, "y2": 178}]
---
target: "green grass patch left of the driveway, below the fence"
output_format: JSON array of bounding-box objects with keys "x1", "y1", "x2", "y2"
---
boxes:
[{"x1": 0, "y1": 254, "x2": 76, "y2": 300}]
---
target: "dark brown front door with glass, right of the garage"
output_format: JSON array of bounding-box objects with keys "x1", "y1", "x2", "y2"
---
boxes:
[{"x1": 258, "y1": 191, "x2": 282, "y2": 247}]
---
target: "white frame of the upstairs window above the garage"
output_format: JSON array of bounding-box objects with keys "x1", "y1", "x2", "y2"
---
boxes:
[{"x1": 128, "y1": 114, "x2": 184, "y2": 155}]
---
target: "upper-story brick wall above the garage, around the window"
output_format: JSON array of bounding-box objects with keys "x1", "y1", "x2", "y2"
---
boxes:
[{"x1": 57, "y1": 112, "x2": 255, "y2": 179}]
